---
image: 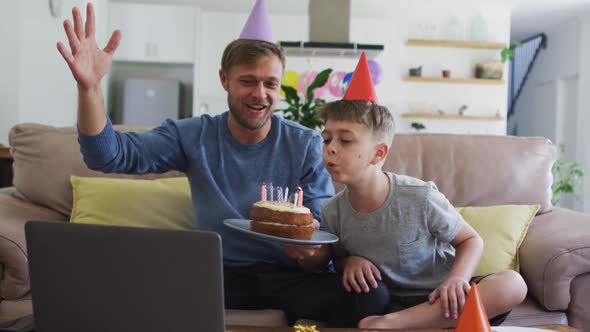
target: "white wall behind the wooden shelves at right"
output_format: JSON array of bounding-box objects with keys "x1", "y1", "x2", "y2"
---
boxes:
[{"x1": 378, "y1": 0, "x2": 510, "y2": 135}]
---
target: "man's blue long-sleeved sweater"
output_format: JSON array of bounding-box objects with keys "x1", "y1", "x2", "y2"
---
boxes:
[{"x1": 78, "y1": 112, "x2": 334, "y2": 266}]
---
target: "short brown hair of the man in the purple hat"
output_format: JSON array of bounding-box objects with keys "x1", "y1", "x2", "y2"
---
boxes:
[{"x1": 221, "y1": 39, "x2": 286, "y2": 73}]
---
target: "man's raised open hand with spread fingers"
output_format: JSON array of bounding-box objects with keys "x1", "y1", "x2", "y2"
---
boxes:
[{"x1": 57, "y1": 3, "x2": 121, "y2": 90}]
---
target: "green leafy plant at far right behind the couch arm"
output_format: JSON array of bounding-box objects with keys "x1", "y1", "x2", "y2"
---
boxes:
[{"x1": 551, "y1": 160, "x2": 584, "y2": 205}]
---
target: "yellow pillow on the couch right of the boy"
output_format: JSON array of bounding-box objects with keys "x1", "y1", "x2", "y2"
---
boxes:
[{"x1": 457, "y1": 205, "x2": 540, "y2": 275}]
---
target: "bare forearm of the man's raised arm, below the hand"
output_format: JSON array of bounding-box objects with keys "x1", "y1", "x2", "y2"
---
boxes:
[{"x1": 78, "y1": 85, "x2": 107, "y2": 135}]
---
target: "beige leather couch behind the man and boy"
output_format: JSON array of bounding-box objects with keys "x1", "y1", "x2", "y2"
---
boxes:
[{"x1": 0, "y1": 124, "x2": 590, "y2": 331}]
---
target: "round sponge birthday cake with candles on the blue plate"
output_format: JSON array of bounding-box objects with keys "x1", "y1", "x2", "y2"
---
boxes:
[{"x1": 250, "y1": 184, "x2": 313, "y2": 240}]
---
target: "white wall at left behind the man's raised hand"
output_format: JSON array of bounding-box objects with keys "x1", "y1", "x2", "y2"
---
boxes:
[{"x1": 0, "y1": 0, "x2": 107, "y2": 142}]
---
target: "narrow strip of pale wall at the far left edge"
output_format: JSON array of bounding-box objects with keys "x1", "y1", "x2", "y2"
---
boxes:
[{"x1": 0, "y1": 0, "x2": 22, "y2": 145}]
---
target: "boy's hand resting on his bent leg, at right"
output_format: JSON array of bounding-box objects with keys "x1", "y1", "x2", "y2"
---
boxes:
[{"x1": 428, "y1": 278, "x2": 471, "y2": 319}]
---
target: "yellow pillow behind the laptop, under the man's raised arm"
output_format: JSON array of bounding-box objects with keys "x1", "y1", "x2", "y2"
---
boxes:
[{"x1": 70, "y1": 176, "x2": 195, "y2": 229}]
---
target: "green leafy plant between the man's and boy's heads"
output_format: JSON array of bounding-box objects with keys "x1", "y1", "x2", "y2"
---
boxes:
[{"x1": 275, "y1": 68, "x2": 332, "y2": 129}]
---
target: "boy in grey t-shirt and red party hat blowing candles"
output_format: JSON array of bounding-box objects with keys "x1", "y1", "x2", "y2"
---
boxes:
[{"x1": 319, "y1": 54, "x2": 527, "y2": 329}]
